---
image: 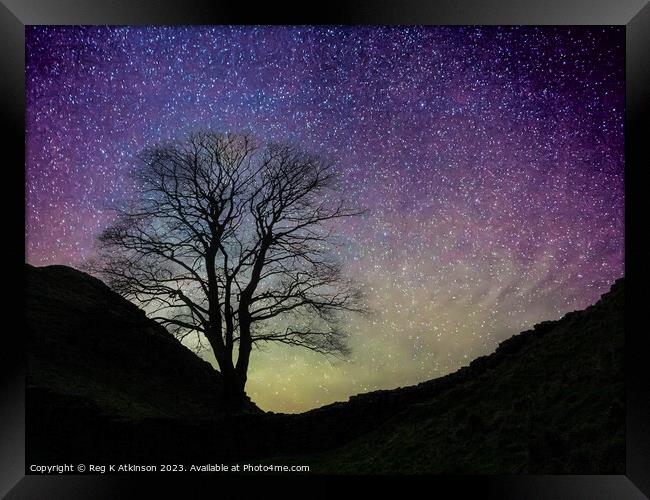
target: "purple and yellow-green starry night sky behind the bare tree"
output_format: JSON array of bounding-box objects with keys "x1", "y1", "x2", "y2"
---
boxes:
[{"x1": 26, "y1": 27, "x2": 624, "y2": 412}]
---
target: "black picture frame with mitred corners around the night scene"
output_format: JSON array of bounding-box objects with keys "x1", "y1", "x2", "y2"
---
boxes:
[{"x1": 6, "y1": 0, "x2": 650, "y2": 499}]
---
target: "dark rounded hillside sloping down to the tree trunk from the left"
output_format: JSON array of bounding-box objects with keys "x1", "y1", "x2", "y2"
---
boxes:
[{"x1": 25, "y1": 264, "x2": 259, "y2": 462}]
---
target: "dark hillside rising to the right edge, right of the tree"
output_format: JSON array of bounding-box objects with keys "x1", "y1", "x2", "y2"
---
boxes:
[{"x1": 274, "y1": 280, "x2": 625, "y2": 474}]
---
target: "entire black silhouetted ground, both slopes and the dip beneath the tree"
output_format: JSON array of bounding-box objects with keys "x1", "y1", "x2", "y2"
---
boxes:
[{"x1": 26, "y1": 266, "x2": 625, "y2": 474}]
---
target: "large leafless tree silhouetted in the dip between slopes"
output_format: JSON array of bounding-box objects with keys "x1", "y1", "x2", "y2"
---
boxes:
[{"x1": 89, "y1": 132, "x2": 361, "y2": 408}]
